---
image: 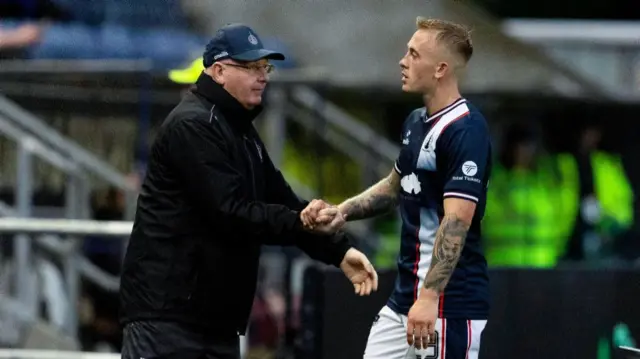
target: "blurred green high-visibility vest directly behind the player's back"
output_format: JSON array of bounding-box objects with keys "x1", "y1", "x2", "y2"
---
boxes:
[{"x1": 482, "y1": 161, "x2": 570, "y2": 267}]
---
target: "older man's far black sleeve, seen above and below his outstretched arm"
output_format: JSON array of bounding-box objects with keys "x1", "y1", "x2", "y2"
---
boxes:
[{"x1": 258, "y1": 147, "x2": 352, "y2": 267}]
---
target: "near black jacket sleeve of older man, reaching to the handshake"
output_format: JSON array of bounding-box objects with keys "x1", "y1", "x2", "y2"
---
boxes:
[{"x1": 165, "y1": 119, "x2": 306, "y2": 244}]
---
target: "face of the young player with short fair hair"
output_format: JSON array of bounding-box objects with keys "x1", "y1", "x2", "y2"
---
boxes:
[{"x1": 400, "y1": 29, "x2": 448, "y2": 94}]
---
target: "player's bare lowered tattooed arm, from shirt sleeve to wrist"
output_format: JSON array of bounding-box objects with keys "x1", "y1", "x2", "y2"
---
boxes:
[{"x1": 421, "y1": 198, "x2": 476, "y2": 298}]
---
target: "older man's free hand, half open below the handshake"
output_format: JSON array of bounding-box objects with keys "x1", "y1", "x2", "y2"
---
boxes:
[{"x1": 340, "y1": 248, "x2": 378, "y2": 296}]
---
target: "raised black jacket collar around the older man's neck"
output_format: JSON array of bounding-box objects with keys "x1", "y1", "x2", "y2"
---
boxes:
[{"x1": 192, "y1": 73, "x2": 262, "y2": 132}]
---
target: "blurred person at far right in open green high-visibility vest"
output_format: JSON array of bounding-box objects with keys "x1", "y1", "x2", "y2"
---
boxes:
[{"x1": 558, "y1": 121, "x2": 634, "y2": 261}]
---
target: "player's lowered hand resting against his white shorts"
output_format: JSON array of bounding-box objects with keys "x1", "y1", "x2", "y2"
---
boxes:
[{"x1": 407, "y1": 291, "x2": 438, "y2": 349}]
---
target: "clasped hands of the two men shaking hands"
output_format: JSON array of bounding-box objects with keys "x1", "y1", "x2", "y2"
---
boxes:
[{"x1": 300, "y1": 199, "x2": 347, "y2": 235}]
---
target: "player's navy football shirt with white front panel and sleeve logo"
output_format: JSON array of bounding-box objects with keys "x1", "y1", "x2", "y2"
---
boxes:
[{"x1": 387, "y1": 99, "x2": 491, "y2": 319}]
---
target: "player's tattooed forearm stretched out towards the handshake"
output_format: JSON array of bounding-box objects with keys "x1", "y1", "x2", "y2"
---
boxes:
[{"x1": 338, "y1": 169, "x2": 400, "y2": 221}]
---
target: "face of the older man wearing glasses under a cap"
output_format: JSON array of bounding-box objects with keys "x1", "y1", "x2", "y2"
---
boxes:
[{"x1": 215, "y1": 59, "x2": 272, "y2": 109}]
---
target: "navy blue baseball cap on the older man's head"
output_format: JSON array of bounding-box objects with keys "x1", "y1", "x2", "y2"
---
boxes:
[{"x1": 202, "y1": 23, "x2": 285, "y2": 67}]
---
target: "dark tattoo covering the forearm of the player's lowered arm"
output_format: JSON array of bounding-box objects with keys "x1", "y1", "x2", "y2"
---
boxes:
[{"x1": 424, "y1": 214, "x2": 469, "y2": 293}]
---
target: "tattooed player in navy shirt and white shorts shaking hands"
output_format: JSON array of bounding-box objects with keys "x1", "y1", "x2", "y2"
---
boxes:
[{"x1": 303, "y1": 17, "x2": 492, "y2": 359}]
